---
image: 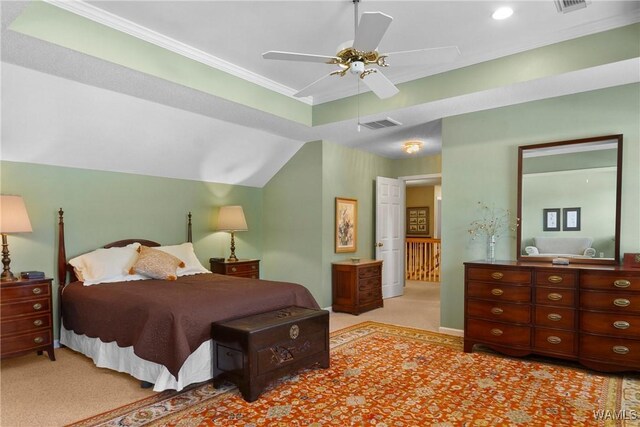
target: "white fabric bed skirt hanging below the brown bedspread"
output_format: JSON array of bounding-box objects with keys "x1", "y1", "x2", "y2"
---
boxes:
[{"x1": 60, "y1": 326, "x2": 213, "y2": 391}]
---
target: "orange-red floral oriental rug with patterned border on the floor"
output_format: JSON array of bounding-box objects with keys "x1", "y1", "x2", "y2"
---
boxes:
[{"x1": 67, "y1": 322, "x2": 640, "y2": 427}]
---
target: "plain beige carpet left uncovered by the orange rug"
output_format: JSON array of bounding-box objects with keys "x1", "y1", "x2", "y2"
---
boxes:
[{"x1": 0, "y1": 282, "x2": 440, "y2": 427}]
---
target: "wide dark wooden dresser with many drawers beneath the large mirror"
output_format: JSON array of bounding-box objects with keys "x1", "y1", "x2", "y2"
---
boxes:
[{"x1": 464, "y1": 261, "x2": 640, "y2": 372}]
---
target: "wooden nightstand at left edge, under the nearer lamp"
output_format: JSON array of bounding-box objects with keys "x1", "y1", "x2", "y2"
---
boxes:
[{"x1": 0, "y1": 279, "x2": 56, "y2": 360}]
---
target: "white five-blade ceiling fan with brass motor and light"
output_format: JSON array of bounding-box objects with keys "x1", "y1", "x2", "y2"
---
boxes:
[{"x1": 262, "y1": 0, "x2": 460, "y2": 99}]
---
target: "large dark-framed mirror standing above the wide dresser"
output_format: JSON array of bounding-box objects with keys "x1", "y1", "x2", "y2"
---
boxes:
[{"x1": 517, "y1": 135, "x2": 622, "y2": 264}]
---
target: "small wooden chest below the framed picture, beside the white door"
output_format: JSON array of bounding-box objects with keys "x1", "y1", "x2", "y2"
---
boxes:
[{"x1": 331, "y1": 260, "x2": 383, "y2": 314}]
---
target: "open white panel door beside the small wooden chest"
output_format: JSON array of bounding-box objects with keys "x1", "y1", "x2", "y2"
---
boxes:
[{"x1": 375, "y1": 176, "x2": 404, "y2": 298}]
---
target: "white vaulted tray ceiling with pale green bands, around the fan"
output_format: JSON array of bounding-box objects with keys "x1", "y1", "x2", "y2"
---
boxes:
[{"x1": 2, "y1": 0, "x2": 640, "y2": 187}]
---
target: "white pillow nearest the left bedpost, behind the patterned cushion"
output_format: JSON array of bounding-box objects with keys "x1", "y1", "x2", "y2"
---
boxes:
[{"x1": 69, "y1": 243, "x2": 148, "y2": 286}]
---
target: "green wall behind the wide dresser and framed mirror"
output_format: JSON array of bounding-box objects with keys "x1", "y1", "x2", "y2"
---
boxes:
[{"x1": 440, "y1": 84, "x2": 640, "y2": 329}]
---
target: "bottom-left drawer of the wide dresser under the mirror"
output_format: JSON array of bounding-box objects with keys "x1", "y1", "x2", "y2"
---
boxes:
[{"x1": 464, "y1": 319, "x2": 531, "y2": 347}]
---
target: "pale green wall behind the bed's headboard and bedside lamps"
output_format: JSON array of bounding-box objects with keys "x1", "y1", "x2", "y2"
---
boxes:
[{"x1": 0, "y1": 161, "x2": 263, "y2": 334}]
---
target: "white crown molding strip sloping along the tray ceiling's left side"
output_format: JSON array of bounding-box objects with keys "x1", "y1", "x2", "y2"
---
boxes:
[{"x1": 43, "y1": 0, "x2": 313, "y2": 105}]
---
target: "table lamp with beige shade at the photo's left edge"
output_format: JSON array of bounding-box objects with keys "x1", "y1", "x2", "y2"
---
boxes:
[{"x1": 0, "y1": 194, "x2": 32, "y2": 282}]
